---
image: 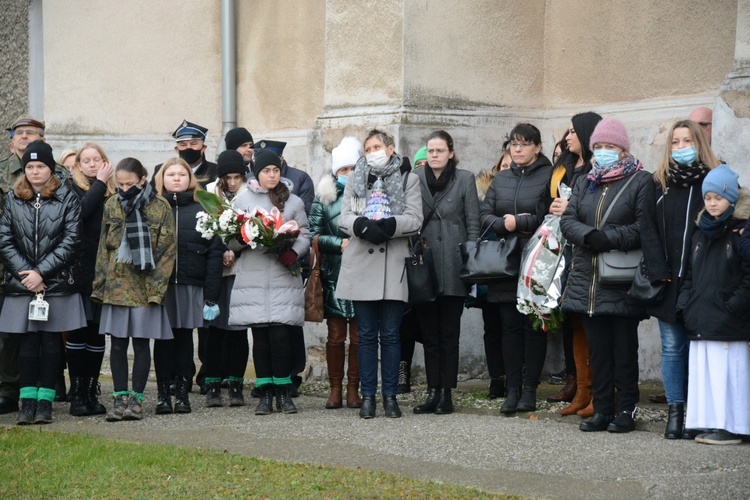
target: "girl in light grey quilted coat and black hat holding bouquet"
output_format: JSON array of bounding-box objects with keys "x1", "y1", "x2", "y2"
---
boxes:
[{"x1": 229, "y1": 149, "x2": 310, "y2": 415}]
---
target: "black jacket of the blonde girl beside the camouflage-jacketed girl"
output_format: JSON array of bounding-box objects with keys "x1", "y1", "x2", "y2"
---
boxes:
[{"x1": 163, "y1": 191, "x2": 226, "y2": 302}]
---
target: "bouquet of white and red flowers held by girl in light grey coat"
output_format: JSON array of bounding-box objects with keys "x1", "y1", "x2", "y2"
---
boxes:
[{"x1": 195, "y1": 191, "x2": 300, "y2": 276}]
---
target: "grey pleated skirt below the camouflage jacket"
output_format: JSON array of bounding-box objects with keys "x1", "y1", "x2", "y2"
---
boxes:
[{"x1": 99, "y1": 304, "x2": 174, "y2": 340}]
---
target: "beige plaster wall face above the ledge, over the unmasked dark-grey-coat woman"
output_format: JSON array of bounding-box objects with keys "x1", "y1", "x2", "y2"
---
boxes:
[{"x1": 404, "y1": 0, "x2": 545, "y2": 108}]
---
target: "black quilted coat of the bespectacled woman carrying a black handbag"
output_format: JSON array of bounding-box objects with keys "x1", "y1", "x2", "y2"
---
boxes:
[{"x1": 479, "y1": 154, "x2": 552, "y2": 303}]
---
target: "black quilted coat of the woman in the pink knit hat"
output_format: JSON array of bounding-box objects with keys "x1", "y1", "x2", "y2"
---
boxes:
[{"x1": 560, "y1": 170, "x2": 654, "y2": 318}]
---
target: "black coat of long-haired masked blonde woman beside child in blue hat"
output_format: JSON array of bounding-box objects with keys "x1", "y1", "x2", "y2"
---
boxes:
[{"x1": 641, "y1": 169, "x2": 705, "y2": 323}]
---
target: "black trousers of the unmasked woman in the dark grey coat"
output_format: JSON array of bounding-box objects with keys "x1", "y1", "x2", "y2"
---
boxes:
[{"x1": 415, "y1": 295, "x2": 464, "y2": 389}]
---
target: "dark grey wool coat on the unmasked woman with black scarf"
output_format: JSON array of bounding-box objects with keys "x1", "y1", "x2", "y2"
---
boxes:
[{"x1": 416, "y1": 166, "x2": 479, "y2": 297}]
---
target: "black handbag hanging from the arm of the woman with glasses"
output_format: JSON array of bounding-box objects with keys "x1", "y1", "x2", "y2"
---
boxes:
[{"x1": 458, "y1": 223, "x2": 521, "y2": 284}]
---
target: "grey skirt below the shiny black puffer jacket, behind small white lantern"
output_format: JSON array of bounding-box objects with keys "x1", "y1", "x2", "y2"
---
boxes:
[{"x1": 0, "y1": 293, "x2": 86, "y2": 333}]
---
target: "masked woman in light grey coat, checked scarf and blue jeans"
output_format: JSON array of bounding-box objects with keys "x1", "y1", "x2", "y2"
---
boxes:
[{"x1": 336, "y1": 130, "x2": 422, "y2": 418}]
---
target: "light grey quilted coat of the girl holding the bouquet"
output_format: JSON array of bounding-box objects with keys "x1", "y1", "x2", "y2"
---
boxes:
[{"x1": 229, "y1": 183, "x2": 310, "y2": 326}]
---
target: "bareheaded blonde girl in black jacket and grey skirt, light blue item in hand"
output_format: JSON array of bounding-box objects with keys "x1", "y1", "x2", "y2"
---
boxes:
[{"x1": 154, "y1": 158, "x2": 224, "y2": 414}]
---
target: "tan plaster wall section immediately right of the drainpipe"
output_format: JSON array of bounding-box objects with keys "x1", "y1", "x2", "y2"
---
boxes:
[{"x1": 238, "y1": 0, "x2": 326, "y2": 132}]
